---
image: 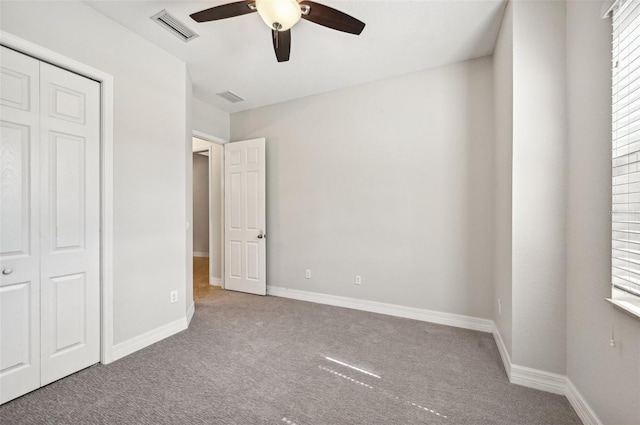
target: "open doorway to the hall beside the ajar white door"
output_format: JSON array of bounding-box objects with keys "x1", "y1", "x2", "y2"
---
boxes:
[{"x1": 192, "y1": 137, "x2": 224, "y2": 300}]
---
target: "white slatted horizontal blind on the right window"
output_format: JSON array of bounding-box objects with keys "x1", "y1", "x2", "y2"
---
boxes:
[{"x1": 611, "y1": 0, "x2": 640, "y2": 296}]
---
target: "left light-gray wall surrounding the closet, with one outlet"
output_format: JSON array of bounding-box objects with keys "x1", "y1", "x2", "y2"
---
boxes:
[{"x1": 0, "y1": 2, "x2": 190, "y2": 344}]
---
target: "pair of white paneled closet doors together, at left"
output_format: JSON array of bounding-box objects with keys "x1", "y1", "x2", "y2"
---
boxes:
[{"x1": 0, "y1": 47, "x2": 100, "y2": 403}]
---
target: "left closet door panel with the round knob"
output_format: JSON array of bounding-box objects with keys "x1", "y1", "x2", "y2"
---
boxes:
[{"x1": 0, "y1": 47, "x2": 40, "y2": 403}]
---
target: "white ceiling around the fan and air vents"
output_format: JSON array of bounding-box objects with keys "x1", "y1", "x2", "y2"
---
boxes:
[{"x1": 87, "y1": 0, "x2": 505, "y2": 112}]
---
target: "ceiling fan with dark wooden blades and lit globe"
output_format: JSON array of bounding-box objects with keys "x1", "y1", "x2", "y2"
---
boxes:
[{"x1": 190, "y1": 0, "x2": 365, "y2": 62}]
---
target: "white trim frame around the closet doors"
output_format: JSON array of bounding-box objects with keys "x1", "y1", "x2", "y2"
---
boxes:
[{"x1": 0, "y1": 30, "x2": 114, "y2": 364}]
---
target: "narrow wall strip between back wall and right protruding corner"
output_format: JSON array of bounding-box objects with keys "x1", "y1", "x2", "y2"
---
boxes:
[{"x1": 492, "y1": 3, "x2": 513, "y2": 356}]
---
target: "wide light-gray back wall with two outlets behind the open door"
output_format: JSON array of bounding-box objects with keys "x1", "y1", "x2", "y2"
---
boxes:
[{"x1": 231, "y1": 58, "x2": 494, "y2": 318}]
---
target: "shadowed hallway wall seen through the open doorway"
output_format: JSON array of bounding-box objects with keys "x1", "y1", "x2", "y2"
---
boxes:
[{"x1": 193, "y1": 153, "x2": 209, "y2": 254}]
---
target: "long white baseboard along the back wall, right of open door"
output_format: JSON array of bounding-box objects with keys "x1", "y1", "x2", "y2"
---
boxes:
[{"x1": 267, "y1": 286, "x2": 494, "y2": 332}]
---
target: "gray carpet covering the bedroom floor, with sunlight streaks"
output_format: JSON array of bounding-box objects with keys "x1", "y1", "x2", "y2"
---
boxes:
[{"x1": 0, "y1": 291, "x2": 581, "y2": 425}]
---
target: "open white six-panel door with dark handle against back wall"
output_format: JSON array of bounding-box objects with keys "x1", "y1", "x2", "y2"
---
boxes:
[{"x1": 224, "y1": 139, "x2": 267, "y2": 295}]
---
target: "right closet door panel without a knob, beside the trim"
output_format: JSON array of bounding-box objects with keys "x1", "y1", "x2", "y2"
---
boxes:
[{"x1": 40, "y1": 63, "x2": 100, "y2": 385}]
